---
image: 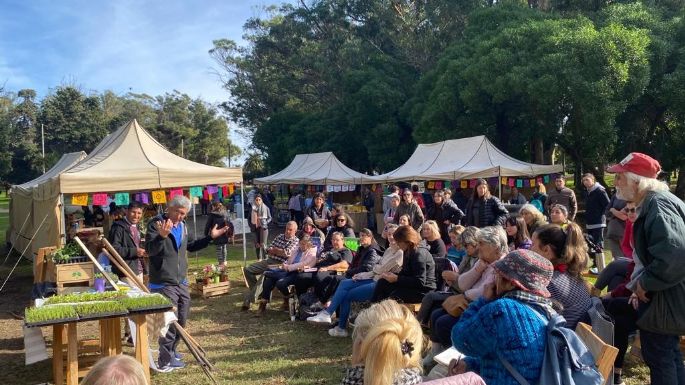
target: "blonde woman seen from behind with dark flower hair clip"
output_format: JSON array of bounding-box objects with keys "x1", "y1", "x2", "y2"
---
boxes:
[{"x1": 342, "y1": 300, "x2": 423, "y2": 385}]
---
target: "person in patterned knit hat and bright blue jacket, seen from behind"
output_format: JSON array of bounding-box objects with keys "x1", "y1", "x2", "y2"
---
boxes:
[{"x1": 426, "y1": 249, "x2": 554, "y2": 385}]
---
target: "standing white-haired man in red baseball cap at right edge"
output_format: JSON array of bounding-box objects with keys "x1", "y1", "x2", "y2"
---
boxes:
[{"x1": 607, "y1": 152, "x2": 685, "y2": 385}]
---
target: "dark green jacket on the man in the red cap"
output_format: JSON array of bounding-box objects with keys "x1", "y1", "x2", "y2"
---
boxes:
[{"x1": 633, "y1": 191, "x2": 685, "y2": 334}]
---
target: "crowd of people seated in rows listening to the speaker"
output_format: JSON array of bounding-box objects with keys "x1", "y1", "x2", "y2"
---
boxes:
[{"x1": 246, "y1": 171, "x2": 680, "y2": 385}]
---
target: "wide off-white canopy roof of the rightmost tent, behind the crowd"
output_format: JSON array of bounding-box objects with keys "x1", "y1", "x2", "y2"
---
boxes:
[{"x1": 368, "y1": 135, "x2": 563, "y2": 183}]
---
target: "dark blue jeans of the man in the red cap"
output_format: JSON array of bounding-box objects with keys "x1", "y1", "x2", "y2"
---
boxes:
[{"x1": 640, "y1": 330, "x2": 685, "y2": 385}]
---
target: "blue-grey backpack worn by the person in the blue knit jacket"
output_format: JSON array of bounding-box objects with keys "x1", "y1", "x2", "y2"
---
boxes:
[{"x1": 498, "y1": 309, "x2": 604, "y2": 385}]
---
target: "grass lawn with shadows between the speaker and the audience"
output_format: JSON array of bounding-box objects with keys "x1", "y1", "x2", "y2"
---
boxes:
[{"x1": 0, "y1": 210, "x2": 649, "y2": 385}]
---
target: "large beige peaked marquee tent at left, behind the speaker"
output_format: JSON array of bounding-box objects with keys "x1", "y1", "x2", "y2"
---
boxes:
[{"x1": 8, "y1": 120, "x2": 242, "y2": 253}]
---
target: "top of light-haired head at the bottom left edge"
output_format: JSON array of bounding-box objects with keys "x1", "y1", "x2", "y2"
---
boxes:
[{"x1": 80, "y1": 354, "x2": 149, "y2": 385}]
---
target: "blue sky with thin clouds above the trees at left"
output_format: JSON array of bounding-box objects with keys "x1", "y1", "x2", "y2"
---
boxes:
[{"x1": 0, "y1": 0, "x2": 283, "y2": 155}]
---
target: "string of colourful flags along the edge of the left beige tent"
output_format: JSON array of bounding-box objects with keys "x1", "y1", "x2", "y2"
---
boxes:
[{"x1": 71, "y1": 183, "x2": 236, "y2": 206}]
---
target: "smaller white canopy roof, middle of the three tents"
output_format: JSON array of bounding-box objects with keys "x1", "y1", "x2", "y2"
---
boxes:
[{"x1": 254, "y1": 152, "x2": 375, "y2": 185}]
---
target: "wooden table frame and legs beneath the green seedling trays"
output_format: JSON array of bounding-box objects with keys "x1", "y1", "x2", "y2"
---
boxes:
[{"x1": 47, "y1": 308, "x2": 170, "y2": 385}]
